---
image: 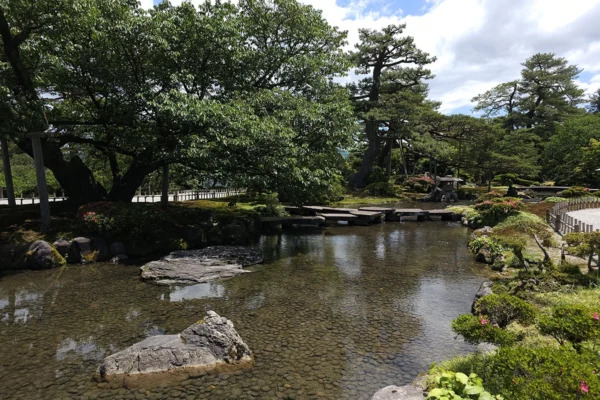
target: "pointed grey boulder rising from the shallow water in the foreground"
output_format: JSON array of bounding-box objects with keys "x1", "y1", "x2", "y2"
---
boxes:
[{"x1": 96, "y1": 311, "x2": 254, "y2": 388}]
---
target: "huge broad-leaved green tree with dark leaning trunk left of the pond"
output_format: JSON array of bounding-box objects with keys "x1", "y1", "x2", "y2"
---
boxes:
[{"x1": 0, "y1": 0, "x2": 352, "y2": 204}]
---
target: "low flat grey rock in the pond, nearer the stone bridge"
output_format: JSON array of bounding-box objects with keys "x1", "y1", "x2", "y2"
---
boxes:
[{"x1": 140, "y1": 246, "x2": 263, "y2": 285}]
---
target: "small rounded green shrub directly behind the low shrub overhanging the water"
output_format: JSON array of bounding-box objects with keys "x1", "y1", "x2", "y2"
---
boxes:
[{"x1": 475, "y1": 294, "x2": 535, "y2": 328}]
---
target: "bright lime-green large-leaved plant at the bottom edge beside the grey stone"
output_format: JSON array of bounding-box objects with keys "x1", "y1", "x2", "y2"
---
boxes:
[{"x1": 427, "y1": 372, "x2": 503, "y2": 400}]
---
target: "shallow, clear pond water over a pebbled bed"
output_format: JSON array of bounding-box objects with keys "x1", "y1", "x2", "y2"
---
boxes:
[{"x1": 0, "y1": 222, "x2": 482, "y2": 400}]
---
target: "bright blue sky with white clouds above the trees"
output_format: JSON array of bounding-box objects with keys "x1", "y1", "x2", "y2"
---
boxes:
[{"x1": 141, "y1": 0, "x2": 600, "y2": 114}]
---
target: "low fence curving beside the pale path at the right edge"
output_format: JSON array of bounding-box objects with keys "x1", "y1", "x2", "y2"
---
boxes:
[{"x1": 547, "y1": 197, "x2": 600, "y2": 235}]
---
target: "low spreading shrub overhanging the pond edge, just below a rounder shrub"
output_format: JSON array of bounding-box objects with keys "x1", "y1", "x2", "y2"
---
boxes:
[{"x1": 452, "y1": 314, "x2": 519, "y2": 346}]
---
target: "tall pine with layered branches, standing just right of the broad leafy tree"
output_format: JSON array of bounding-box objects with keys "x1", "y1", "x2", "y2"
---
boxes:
[{"x1": 349, "y1": 25, "x2": 435, "y2": 187}]
